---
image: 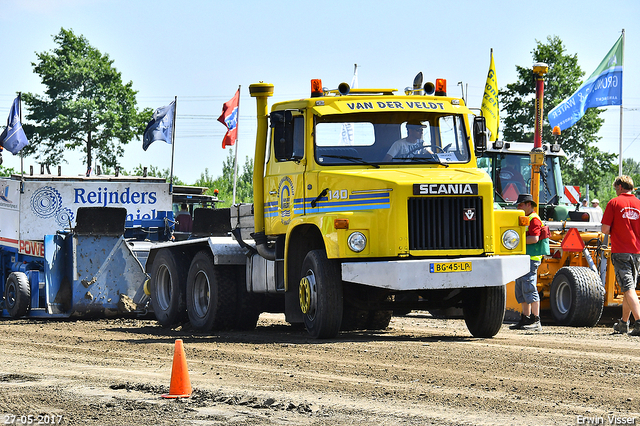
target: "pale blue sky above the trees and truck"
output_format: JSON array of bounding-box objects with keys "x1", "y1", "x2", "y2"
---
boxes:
[{"x1": 0, "y1": 0, "x2": 640, "y2": 185}]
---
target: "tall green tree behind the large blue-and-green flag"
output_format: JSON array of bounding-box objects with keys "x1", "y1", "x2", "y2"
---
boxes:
[{"x1": 500, "y1": 36, "x2": 616, "y2": 195}]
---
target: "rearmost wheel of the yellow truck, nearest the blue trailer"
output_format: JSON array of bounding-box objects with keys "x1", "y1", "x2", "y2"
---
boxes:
[{"x1": 149, "y1": 249, "x2": 189, "y2": 327}]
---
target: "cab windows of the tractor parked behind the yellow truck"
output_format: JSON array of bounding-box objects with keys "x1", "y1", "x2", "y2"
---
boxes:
[{"x1": 478, "y1": 153, "x2": 561, "y2": 204}]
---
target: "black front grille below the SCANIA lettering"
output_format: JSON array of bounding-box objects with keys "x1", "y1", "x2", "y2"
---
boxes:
[{"x1": 408, "y1": 197, "x2": 484, "y2": 250}]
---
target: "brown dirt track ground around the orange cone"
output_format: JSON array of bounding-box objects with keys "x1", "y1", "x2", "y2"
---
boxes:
[{"x1": 0, "y1": 309, "x2": 640, "y2": 426}]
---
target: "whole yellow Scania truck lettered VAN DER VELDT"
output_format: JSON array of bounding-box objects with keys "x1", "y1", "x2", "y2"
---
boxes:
[{"x1": 146, "y1": 75, "x2": 529, "y2": 338}]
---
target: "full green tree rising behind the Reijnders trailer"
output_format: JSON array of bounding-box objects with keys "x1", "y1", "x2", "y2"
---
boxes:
[{"x1": 22, "y1": 28, "x2": 152, "y2": 171}]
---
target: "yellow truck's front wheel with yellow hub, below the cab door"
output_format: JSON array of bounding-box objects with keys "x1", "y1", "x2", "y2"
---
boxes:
[{"x1": 299, "y1": 250, "x2": 343, "y2": 339}]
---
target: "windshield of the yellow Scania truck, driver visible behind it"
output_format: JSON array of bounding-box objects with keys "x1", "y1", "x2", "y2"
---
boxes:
[{"x1": 314, "y1": 113, "x2": 470, "y2": 165}]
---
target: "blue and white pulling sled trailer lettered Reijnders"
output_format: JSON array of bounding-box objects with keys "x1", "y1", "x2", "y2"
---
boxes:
[{"x1": 0, "y1": 175, "x2": 173, "y2": 318}]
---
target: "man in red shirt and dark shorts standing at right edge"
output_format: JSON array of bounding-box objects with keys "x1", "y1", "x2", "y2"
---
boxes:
[{"x1": 602, "y1": 176, "x2": 640, "y2": 336}]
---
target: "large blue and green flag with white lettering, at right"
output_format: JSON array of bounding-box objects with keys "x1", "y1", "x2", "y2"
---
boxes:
[{"x1": 548, "y1": 36, "x2": 624, "y2": 130}]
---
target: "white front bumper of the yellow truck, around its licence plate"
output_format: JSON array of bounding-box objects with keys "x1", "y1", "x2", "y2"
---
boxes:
[{"x1": 342, "y1": 255, "x2": 530, "y2": 290}]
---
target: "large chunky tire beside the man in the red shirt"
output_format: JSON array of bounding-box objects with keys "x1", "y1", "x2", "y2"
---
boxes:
[{"x1": 550, "y1": 266, "x2": 604, "y2": 327}]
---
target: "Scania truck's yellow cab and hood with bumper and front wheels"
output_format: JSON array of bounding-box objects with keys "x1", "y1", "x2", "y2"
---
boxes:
[{"x1": 250, "y1": 80, "x2": 528, "y2": 337}]
